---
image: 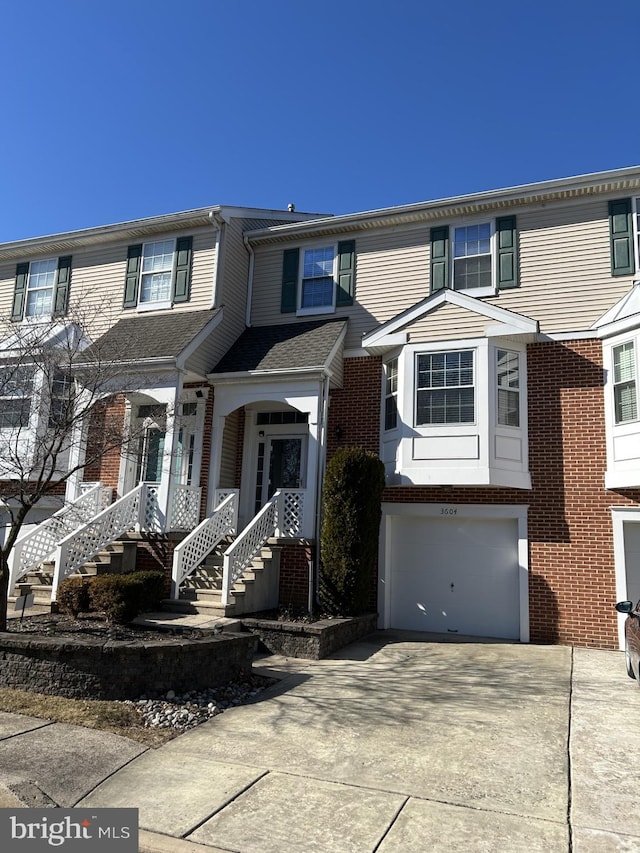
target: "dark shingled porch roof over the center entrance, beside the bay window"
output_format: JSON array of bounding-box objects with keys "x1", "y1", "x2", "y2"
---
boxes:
[{"x1": 212, "y1": 320, "x2": 347, "y2": 373}]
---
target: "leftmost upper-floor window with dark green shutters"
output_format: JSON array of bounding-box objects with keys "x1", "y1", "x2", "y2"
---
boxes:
[{"x1": 11, "y1": 255, "x2": 71, "y2": 323}]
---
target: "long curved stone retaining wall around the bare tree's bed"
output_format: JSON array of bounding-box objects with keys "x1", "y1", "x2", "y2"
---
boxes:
[{"x1": 0, "y1": 633, "x2": 258, "y2": 699}]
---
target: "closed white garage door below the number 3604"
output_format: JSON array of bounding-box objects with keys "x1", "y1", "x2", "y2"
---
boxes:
[{"x1": 390, "y1": 516, "x2": 520, "y2": 639}]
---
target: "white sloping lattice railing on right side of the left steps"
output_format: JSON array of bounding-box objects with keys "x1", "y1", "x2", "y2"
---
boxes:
[{"x1": 51, "y1": 483, "x2": 148, "y2": 601}]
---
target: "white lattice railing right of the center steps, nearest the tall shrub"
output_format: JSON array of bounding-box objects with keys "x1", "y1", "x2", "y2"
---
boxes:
[{"x1": 222, "y1": 489, "x2": 305, "y2": 605}]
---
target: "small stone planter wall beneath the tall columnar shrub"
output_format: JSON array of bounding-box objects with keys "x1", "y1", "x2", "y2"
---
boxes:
[{"x1": 242, "y1": 613, "x2": 377, "y2": 660}]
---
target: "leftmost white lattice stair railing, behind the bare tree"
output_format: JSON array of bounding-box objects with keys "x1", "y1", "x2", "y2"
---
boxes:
[{"x1": 9, "y1": 483, "x2": 112, "y2": 590}]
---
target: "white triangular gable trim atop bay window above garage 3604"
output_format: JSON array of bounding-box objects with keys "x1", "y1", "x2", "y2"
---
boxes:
[{"x1": 362, "y1": 288, "x2": 539, "y2": 354}]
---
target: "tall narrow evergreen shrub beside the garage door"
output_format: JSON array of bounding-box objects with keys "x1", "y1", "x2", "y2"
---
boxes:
[{"x1": 320, "y1": 447, "x2": 384, "y2": 616}]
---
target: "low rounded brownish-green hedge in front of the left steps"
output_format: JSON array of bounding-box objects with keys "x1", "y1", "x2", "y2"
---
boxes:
[{"x1": 58, "y1": 572, "x2": 164, "y2": 623}]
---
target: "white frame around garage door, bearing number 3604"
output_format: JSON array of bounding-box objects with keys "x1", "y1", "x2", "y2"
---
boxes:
[{"x1": 378, "y1": 501, "x2": 529, "y2": 643}]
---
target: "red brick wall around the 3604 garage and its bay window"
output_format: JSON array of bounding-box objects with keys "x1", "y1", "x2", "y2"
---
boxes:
[{"x1": 316, "y1": 340, "x2": 640, "y2": 648}]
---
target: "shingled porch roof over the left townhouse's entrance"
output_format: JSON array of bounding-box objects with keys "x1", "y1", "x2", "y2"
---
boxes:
[{"x1": 81, "y1": 309, "x2": 220, "y2": 362}]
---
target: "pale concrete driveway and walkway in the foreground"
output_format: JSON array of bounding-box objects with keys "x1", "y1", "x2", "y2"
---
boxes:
[{"x1": 0, "y1": 632, "x2": 640, "y2": 853}]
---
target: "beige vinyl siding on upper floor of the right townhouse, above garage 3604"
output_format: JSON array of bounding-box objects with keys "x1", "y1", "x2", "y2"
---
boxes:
[{"x1": 252, "y1": 195, "x2": 633, "y2": 350}]
